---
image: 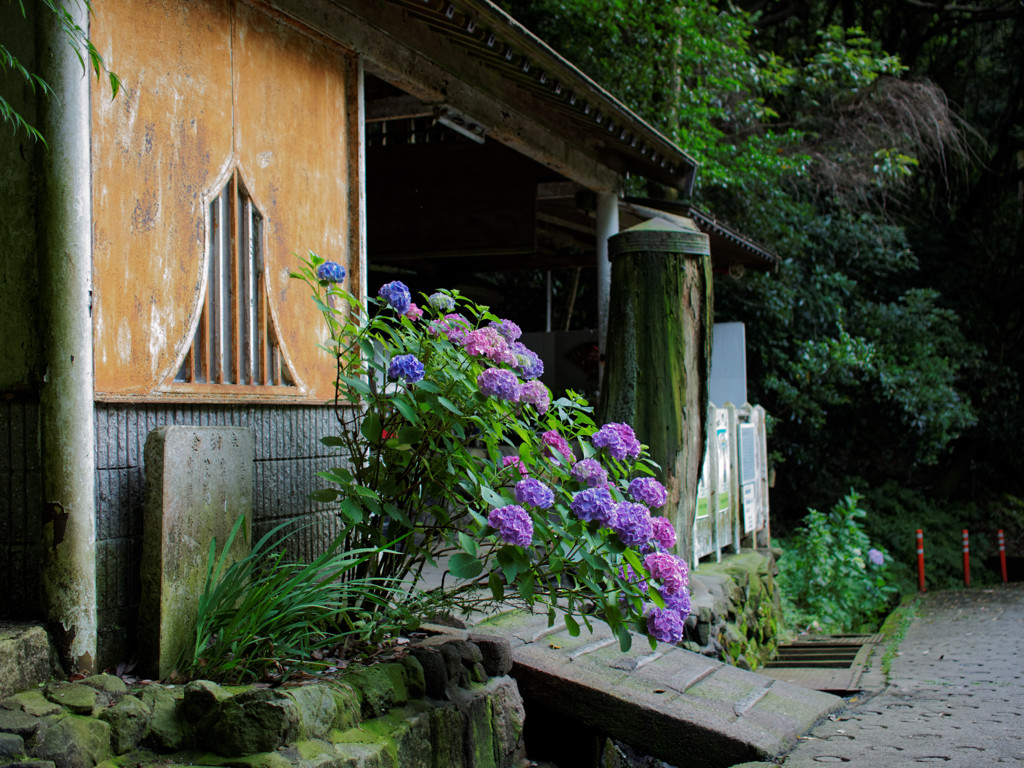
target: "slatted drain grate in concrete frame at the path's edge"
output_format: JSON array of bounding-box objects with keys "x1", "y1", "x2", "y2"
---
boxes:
[{"x1": 758, "y1": 634, "x2": 882, "y2": 695}]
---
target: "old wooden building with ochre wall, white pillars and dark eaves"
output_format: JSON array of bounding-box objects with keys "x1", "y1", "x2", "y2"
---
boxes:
[{"x1": 0, "y1": 0, "x2": 767, "y2": 669}]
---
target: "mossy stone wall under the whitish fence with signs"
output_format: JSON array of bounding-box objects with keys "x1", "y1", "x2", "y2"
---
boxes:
[{"x1": 683, "y1": 550, "x2": 782, "y2": 670}]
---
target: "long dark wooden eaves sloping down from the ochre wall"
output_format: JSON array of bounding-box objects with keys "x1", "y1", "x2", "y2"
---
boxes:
[{"x1": 260, "y1": 0, "x2": 697, "y2": 196}]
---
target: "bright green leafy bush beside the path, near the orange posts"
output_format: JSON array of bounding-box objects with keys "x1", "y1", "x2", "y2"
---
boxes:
[{"x1": 778, "y1": 490, "x2": 896, "y2": 633}]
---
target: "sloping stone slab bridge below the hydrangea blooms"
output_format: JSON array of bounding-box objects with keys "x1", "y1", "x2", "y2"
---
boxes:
[{"x1": 473, "y1": 611, "x2": 844, "y2": 768}]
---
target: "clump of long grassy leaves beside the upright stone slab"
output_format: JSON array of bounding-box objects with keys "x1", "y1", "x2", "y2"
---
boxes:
[{"x1": 178, "y1": 516, "x2": 409, "y2": 683}]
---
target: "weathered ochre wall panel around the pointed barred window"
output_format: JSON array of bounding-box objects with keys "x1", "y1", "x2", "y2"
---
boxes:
[{"x1": 91, "y1": 0, "x2": 359, "y2": 401}]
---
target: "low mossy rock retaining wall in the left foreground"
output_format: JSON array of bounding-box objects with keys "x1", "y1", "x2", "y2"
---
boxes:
[{"x1": 0, "y1": 636, "x2": 525, "y2": 768}]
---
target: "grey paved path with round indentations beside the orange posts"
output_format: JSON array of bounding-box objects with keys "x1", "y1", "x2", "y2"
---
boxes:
[{"x1": 770, "y1": 584, "x2": 1024, "y2": 768}]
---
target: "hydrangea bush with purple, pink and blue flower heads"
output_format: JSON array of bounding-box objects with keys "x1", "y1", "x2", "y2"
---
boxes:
[{"x1": 293, "y1": 252, "x2": 689, "y2": 648}]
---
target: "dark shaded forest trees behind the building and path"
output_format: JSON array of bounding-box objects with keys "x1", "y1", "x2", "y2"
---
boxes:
[{"x1": 504, "y1": 0, "x2": 1024, "y2": 582}]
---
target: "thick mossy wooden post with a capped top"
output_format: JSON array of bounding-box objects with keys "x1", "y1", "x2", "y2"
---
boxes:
[{"x1": 599, "y1": 219, "x2": 712, "y2": 556}]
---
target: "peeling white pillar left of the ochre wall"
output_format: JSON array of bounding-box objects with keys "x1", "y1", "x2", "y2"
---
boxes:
[{"x1": 37, "y1": 2, "x2": 97, "y2": 673}]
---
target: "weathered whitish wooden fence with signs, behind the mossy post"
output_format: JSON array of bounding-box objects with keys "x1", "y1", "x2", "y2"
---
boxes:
[{"x1": 690, "y1": 402, "x2": 771, "y2": 567}]
